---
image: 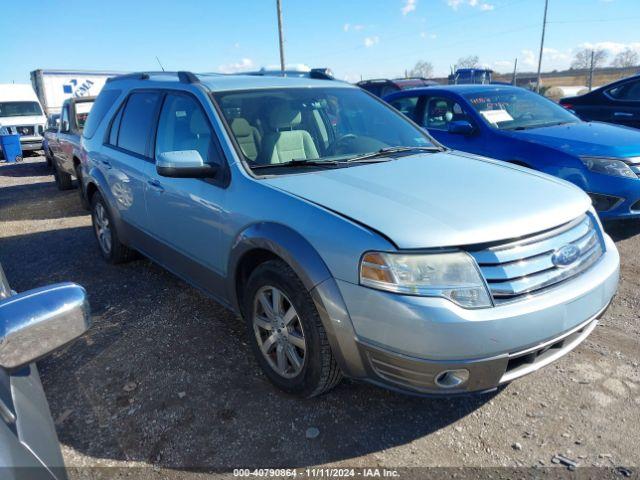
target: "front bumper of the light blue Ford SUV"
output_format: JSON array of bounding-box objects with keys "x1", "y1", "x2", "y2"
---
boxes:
[{"x1": 312, "y1": 236, "x2": 619, "y2": 395}]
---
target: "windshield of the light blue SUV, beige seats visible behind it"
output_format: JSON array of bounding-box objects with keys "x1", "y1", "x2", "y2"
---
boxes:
[{"x1": 214, "y1": 88, "x2": 433, "y2": 168}]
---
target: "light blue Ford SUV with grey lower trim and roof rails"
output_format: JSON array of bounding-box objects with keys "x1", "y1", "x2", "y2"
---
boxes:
[{"x1": 82, "y1": 72, "x2": 619, "y2": 397}]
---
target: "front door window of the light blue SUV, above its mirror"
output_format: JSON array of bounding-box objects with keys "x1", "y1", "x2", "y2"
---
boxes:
[{"x1": 156, "y1": 94, "x2": 220, "y2": 164}]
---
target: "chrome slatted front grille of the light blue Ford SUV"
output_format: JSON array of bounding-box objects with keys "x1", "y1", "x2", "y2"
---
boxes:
[{"x1": 469, "y1": 214, "x2": 604, "y2": 304}]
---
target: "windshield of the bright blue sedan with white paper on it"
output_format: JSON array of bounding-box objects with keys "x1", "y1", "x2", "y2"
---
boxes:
[{"x1": 464, "y1": 89, "x2": 578, "y2": 130}]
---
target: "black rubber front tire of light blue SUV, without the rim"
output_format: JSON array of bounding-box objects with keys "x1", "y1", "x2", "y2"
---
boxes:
[{"x1": 243, "y1": 260, "x2": 342, "y2": 398}]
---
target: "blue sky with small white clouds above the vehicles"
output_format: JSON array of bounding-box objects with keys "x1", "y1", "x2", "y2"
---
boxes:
[{"x1": 0, "y1": 0, "x2": 640, "y2": 83}]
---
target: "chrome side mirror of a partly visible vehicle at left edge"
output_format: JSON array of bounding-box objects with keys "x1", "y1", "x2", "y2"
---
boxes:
[{"x1": 0, "y1": 283, "x2": 91, "y2": 370}]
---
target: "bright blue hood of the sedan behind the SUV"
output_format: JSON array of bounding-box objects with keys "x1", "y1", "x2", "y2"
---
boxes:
[{"x1": 502, "y1": 122, "x2": 640, "y2": 157}]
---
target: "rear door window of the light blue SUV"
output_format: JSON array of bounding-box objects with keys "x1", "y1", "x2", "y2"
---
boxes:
[{"x1": 117, "y1": 92, "x2": 160, "y2": 156}]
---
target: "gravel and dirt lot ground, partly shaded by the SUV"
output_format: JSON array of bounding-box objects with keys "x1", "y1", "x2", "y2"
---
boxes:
[{"x1": 0, "y1": 158, "x2": 640, "y2": 478}]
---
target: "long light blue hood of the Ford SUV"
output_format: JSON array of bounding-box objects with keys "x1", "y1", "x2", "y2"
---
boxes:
[{"x1": 264, "y1": 152, "x2": 591, "y2": 248}]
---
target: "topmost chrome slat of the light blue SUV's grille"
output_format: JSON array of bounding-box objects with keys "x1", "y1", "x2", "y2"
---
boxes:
[{"x1": 469, "y1": 216, "x2": 591, "y2": 264}]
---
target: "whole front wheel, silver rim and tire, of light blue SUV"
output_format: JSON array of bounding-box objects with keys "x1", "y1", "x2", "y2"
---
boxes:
[{"x1": 244, "y1": 260, "x2": 342, "y2": 397}]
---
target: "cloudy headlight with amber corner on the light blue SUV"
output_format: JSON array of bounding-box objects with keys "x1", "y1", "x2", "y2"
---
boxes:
[{"x1": 360, "y1": 252, "x2": 492, "y2": 308}]
